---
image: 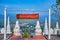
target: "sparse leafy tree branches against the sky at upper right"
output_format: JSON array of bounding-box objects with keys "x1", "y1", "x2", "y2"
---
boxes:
[{"x1": 51, "y1": 0, "x2": 60, "y2": 23}]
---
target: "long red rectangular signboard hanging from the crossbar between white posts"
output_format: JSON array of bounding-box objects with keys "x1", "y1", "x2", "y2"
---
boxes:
[{"x1": 16, "y1": 13, "x2": 39, "y2": 19}]
